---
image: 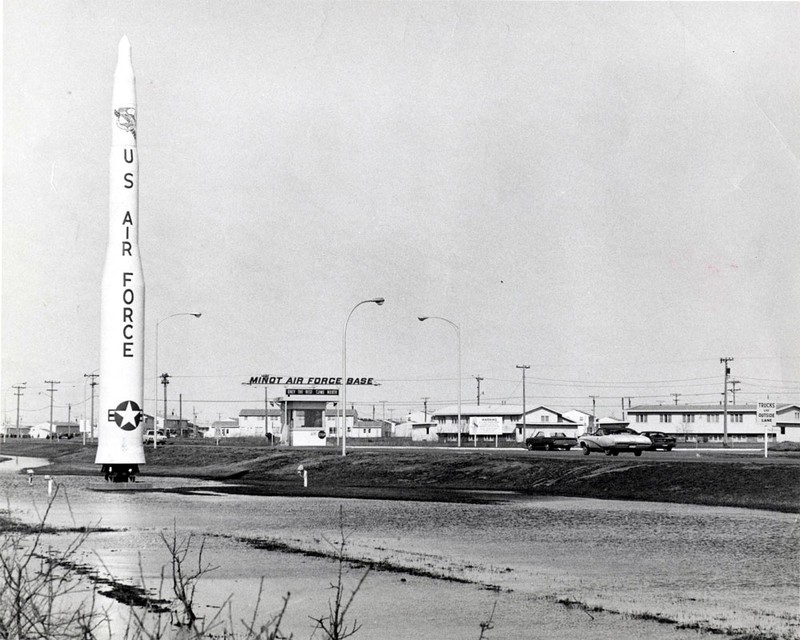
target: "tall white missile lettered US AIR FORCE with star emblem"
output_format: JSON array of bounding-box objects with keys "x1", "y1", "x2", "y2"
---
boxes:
[{"x1": 95, "y1": 37, "x2": 145, "y2": 482}]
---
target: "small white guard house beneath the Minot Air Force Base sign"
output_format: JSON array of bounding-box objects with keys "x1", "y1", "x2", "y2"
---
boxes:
[{"x1": 280, "y1": 387, "x2": 339, "y2": 447}]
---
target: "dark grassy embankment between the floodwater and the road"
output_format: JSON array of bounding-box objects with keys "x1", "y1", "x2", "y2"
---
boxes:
[{"x1": 0, "y1": 440, "x2": 800, "y2": 512}]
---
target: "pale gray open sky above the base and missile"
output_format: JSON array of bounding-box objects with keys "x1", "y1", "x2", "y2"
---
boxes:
[{"x1": 2, "y1": 0, "x2": 800, "y2": 423}]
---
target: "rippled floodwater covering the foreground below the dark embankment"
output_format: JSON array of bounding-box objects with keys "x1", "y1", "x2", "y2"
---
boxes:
[{"x1": 0, "y1": 465, "x2": 800, "y2": 639}]
